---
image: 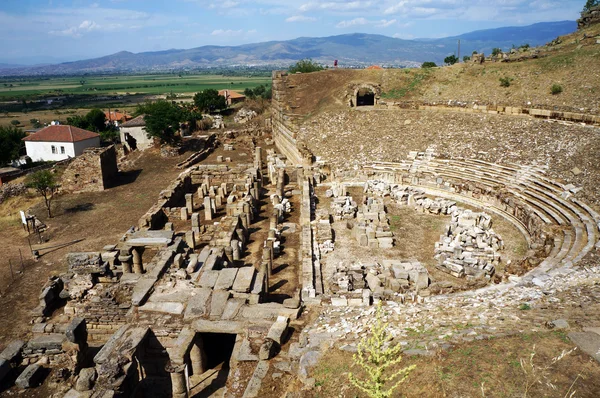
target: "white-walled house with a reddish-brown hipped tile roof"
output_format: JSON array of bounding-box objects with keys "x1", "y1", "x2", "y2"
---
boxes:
[{"x1": 23, "y1": 125, "x2": 100, "y2": 162}]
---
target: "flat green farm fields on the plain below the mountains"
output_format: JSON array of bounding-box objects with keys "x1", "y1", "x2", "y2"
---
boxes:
[{"x1": 0, "y1": 74, "x2": 271, "y2": 99}]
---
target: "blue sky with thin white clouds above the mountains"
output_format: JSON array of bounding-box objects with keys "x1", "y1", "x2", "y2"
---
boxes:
[{"x1": 0, "y1": 0, "x2": 585, "y2": 63}]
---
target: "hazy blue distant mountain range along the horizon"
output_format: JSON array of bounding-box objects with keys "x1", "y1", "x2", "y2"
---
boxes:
[{"x1": 0, "y1": 21, "x2": 577, "y2": 76}]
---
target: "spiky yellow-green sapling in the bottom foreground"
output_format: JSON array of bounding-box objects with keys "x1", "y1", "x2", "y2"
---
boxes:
[{"x1": 348, "y1": 303, "x2": 416, "y2": 398}]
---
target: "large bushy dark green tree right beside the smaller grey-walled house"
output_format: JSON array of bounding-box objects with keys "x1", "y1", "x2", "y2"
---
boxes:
[{"x1": 136, "y1": 100, "x2": 187, "y2": 142}]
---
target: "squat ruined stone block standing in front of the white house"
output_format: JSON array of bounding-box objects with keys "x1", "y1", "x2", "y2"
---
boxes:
[{"x1": 62, "y1": 145, "x2": 119, "y2": 192}]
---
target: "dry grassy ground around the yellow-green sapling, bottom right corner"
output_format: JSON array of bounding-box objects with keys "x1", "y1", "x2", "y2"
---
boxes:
[{"x1": 302, "y1": 332, "x2": 600, "y2": 398}]
